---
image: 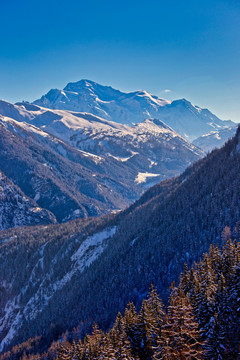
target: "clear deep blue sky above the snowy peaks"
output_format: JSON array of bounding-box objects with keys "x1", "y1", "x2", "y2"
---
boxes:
[{"x1": 0, "y1": 0, "x2": 240, "y2": 122}]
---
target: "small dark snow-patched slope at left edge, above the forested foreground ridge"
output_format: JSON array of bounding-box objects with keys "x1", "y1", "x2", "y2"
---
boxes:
[{"x1": 0, "y1": 170, "x2": 56, "y2": 230}]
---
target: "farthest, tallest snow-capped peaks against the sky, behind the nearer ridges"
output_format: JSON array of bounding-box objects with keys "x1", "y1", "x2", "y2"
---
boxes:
[{"x1": 34, "y1": 80, "x2": 234, "y2": 141}]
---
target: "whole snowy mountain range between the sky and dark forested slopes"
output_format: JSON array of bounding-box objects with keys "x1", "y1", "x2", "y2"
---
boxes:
[{"x1": 0, "y1": 80, "x2": 236, "y2": 228}]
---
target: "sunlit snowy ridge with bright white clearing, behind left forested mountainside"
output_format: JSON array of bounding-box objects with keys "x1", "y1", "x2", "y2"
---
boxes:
[{"x1": 0, "y1": 101, "x2": 203, "y2": 197}]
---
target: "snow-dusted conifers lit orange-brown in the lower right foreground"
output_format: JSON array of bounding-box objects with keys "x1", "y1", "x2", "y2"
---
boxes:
[{"x1": 57, "y1": 232, "x2": 240, "y2": 360}]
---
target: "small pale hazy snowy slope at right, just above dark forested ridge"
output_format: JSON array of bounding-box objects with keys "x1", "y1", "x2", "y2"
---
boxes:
[{"x1": 192, "y1": 124, "x2": 237, "y2": 152}]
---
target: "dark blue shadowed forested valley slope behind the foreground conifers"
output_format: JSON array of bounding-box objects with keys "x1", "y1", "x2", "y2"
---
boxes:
[{"x1": 0, "y1": 122, "x2": 240, "y2": 349}]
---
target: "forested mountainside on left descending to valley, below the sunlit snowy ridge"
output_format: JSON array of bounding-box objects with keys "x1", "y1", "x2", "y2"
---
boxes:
[{"x1": 0, "y1": 112, "x2": 142, "y2": 222}]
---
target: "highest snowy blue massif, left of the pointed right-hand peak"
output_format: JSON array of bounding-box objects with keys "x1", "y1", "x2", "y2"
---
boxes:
[{"x1": 34, "y1": 80, "x2": 168, "y2": 124}]
